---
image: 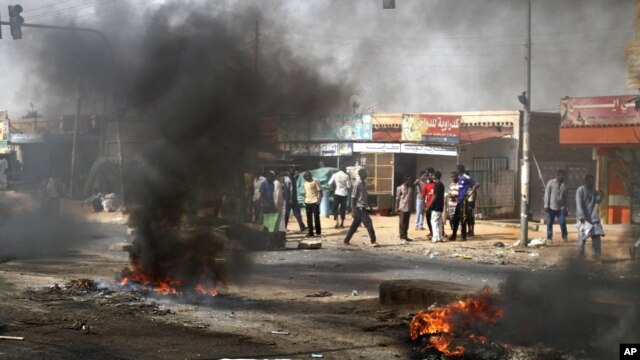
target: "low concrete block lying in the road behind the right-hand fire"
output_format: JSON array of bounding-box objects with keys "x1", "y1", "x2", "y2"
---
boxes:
[{"x1": 380, "y1": 280, "x2": 480, "y2": 306}]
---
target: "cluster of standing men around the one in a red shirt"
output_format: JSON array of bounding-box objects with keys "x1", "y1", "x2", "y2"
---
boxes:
[{"x1": 396, "y1": 165, "x2": 478, "y2": 244}]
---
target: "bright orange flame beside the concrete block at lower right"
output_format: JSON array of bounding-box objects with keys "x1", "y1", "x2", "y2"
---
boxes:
[{"x1": 409, "y1": 288, "x2": 504, "y2": 356}]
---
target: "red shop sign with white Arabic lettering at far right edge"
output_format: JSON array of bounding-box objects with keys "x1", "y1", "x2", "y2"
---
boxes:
[{"x1": 560, "y1": 95, "x2": 640, "y2": 127}]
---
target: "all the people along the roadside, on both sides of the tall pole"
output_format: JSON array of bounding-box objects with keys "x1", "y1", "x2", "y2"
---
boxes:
[{"x1": 244, "y1": 165, "x2": 616, "y2": 258}]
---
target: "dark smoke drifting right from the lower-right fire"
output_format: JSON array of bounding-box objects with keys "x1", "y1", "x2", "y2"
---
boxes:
[{"x1": 497, "y1": 263, "x2": 640, "y2": 359}]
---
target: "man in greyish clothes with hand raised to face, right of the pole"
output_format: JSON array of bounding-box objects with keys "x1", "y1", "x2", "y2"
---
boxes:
[{"x1": 576, "y1": 175, "x2": 604, "y2": 259}]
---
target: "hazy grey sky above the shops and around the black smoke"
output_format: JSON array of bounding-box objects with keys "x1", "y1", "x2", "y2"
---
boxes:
[{"x1": 0, "y1": 0, "x2": 635, "y2": 116}]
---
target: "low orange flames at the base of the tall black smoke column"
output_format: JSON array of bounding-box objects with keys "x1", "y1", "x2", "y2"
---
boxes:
[{"x1": 119, "y1": 260, "x2": 218, "y2": 296}]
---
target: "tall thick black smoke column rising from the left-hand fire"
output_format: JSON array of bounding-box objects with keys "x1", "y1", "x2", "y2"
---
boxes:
[{"x1": 120, "y1": 4, "x2": 352, "y2": 286}]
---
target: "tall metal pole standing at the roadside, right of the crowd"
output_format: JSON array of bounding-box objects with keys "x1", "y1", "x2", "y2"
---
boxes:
[{"x1": 520, "y1": 0, "x2": 531, "y2": 247}]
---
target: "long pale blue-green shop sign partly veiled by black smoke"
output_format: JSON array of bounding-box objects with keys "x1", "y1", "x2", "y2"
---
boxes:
[{"x1": 278, "y1": 114, "x2": 372, "y2": 142}]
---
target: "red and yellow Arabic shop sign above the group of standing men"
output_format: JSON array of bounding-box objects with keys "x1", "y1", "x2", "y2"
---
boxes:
[{"x1": 401, "y1": 114, "x2": 462, "y2": 144}]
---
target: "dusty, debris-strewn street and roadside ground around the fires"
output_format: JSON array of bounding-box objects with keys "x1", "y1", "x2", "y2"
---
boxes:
[{"x1": 0, "y1": 210, "x2": 640, "y2": 359}]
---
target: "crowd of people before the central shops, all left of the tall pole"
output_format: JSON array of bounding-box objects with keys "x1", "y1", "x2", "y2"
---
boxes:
[{"x1": 245, "y1": 165, "x2": 478, "y2": 247}]
